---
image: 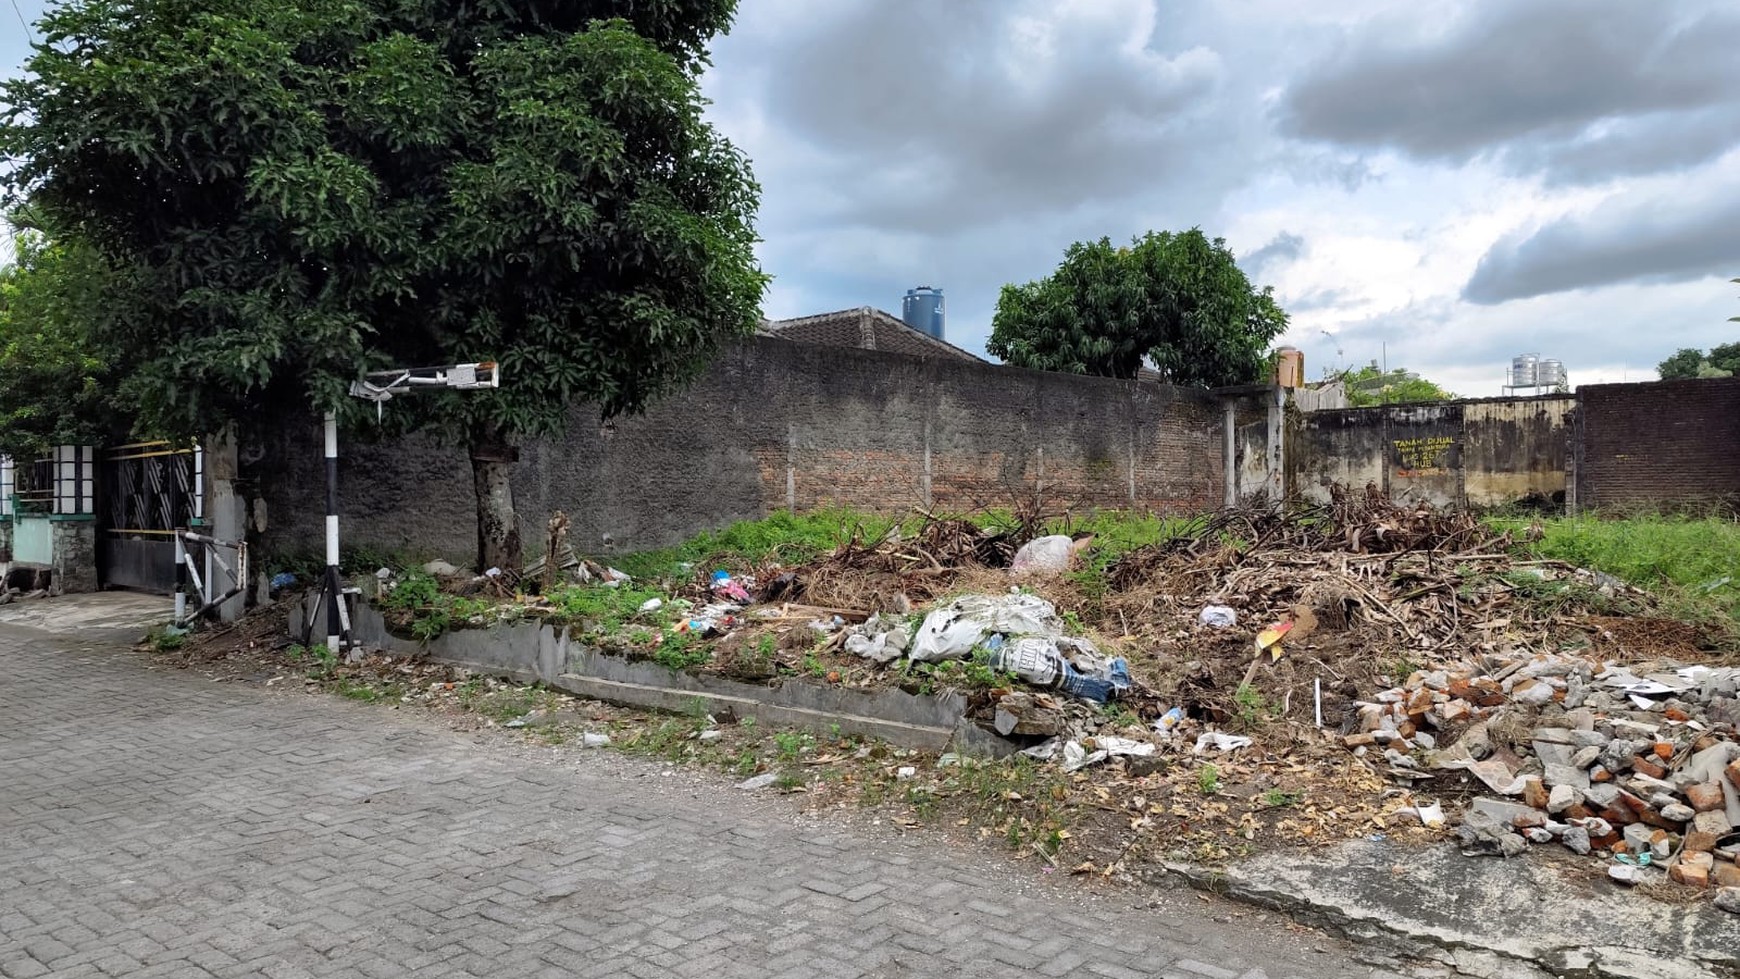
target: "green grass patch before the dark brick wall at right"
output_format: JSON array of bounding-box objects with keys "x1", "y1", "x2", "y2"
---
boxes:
[{"x1": 1493, "y1": 516, "x2": 1740, "y2": 619}]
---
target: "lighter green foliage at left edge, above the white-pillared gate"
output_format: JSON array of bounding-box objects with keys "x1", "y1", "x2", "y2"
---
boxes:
[{"x1": 0, "y1": 216, "x2": 131, "y2": 459}]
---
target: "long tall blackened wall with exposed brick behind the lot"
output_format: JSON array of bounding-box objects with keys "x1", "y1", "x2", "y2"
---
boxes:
[{"x1": 240, "y1": 339, "x2": 1252, "y2": 562}]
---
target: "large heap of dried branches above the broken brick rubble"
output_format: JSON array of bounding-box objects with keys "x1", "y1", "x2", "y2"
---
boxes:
[{"x1": 1107, "y1": 487, "x2": 1650, "y2": 652}]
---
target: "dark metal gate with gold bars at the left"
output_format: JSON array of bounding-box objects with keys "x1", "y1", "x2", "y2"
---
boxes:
[{"x1": 97, "y1": 442, "x2": 204, "y2": 593}]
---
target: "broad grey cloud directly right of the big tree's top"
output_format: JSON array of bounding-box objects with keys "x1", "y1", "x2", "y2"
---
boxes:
[{"x1": 767, "y1": 0, "x2": 1239, "y2": 233}]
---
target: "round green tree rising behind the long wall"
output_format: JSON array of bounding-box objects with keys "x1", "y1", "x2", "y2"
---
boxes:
[{"x1": 985, "y1": 228, "x2": 1288, "y2": 386}]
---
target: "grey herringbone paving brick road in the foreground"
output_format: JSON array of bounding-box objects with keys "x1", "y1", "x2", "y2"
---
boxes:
[{"x1": 0, "y1": 626, "x2": 1426, "y2": 979}]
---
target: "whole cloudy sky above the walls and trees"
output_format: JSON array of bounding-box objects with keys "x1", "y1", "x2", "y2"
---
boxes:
[{"x1": 13, "y1": 0, "x2": 1740, "y2": 395}]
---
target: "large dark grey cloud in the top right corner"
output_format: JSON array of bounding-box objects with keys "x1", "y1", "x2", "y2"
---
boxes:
[{"x1": 1279, "y1": 0, "x2": 1740, "y2": 181}]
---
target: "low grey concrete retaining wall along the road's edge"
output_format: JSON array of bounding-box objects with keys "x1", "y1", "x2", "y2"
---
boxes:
[{"x1": 291, "y1": 605, "x2": 1018, "y2": 756}]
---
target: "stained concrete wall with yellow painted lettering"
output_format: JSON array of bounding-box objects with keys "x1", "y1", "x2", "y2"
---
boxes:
[{"x1": 1288, "y1": 395, "x2": 1576, "y2": 506}]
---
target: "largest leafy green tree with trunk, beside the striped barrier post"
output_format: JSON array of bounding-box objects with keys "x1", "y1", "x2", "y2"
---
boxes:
[{"x1": 0, "y1": 0, "x2": 766, "y2": 567}]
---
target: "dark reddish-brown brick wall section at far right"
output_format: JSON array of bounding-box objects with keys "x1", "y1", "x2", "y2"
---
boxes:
[{"x1": 1576, "y1": 379, "x2": 1740, "y2": 509}]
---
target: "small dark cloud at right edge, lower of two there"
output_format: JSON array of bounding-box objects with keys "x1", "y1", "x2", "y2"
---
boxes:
[{"x1": 1462, "y1": 186, "x2": 1740, "y2": 304}]
